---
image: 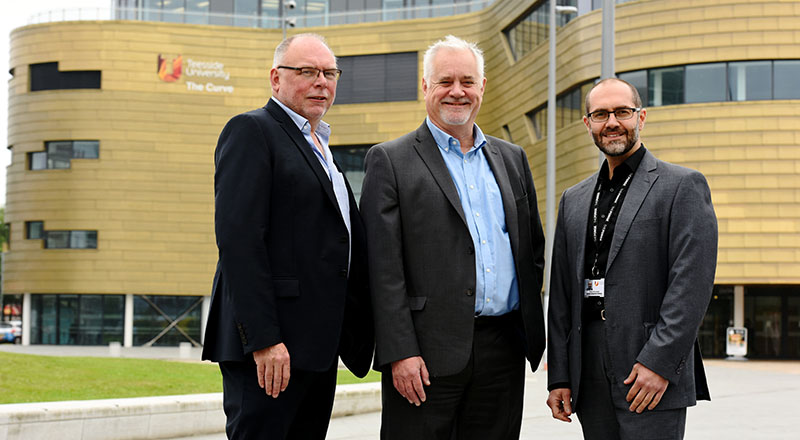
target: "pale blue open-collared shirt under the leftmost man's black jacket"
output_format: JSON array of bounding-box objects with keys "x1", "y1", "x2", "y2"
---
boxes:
[{"x1": 271, "y1": 96, "x2": 353, "y2": 268}]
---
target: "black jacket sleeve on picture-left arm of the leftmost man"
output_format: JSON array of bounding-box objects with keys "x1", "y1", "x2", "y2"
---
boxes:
[{"x1": 214, "y1": 114, "x2": 281, "y2": 354}]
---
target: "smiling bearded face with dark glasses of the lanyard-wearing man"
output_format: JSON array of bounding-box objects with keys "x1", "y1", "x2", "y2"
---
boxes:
[{"x1": 583, "y1": 81, "x2": 647, "y2": 159}]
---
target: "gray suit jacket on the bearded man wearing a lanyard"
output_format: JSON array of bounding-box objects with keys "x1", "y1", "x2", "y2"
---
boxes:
[{"x1": 547, "y1": 147, "x2": 717, "y2": 409}]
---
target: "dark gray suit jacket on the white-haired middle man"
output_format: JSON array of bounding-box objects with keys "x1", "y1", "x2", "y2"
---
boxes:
[{"x1": 361, "y1": 123, "x2": 544, "y2": 376}]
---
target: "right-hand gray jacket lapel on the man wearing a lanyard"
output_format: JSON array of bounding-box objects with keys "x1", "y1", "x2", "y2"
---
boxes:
[{"x1": 606, "y1": 151, "x2": 658, "y2": 273}]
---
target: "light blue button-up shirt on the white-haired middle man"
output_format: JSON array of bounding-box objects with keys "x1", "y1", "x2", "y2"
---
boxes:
[{"x1": 425, "y1": 118, "x2": 519, "y2": 316}]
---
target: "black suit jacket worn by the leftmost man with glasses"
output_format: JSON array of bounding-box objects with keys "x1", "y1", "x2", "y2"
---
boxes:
[{"x1": 203, "y1": 100, "x2": 374, "y2": 376}]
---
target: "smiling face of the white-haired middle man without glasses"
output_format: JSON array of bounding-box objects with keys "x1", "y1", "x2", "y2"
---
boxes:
[{"x1": 422, "y1": 48, "x2": 486, "y2": 136}]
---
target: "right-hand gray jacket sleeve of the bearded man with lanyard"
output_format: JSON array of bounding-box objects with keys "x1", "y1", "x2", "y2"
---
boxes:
[{"x1": 636, "y1": 172, "x2": 717, "y2": 382}]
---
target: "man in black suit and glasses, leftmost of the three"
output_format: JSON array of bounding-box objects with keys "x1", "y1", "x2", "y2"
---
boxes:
[{"x1": 203, "y1": 34, "x2": 374, "y2": 440}]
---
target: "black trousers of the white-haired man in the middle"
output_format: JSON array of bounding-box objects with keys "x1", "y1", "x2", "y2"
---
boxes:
[{"x1": 381, "y1": 312, "x2": 525, "y2": 440}]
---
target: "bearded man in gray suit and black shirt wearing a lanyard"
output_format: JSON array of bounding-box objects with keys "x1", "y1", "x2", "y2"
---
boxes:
[{"x1": 547, "y1": 79, "x2": 717, "y2": 440}]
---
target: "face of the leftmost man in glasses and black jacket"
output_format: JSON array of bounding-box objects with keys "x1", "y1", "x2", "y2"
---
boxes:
[{"x1": 269, "y1": 37, "x2": 336, "y2": 128}]
